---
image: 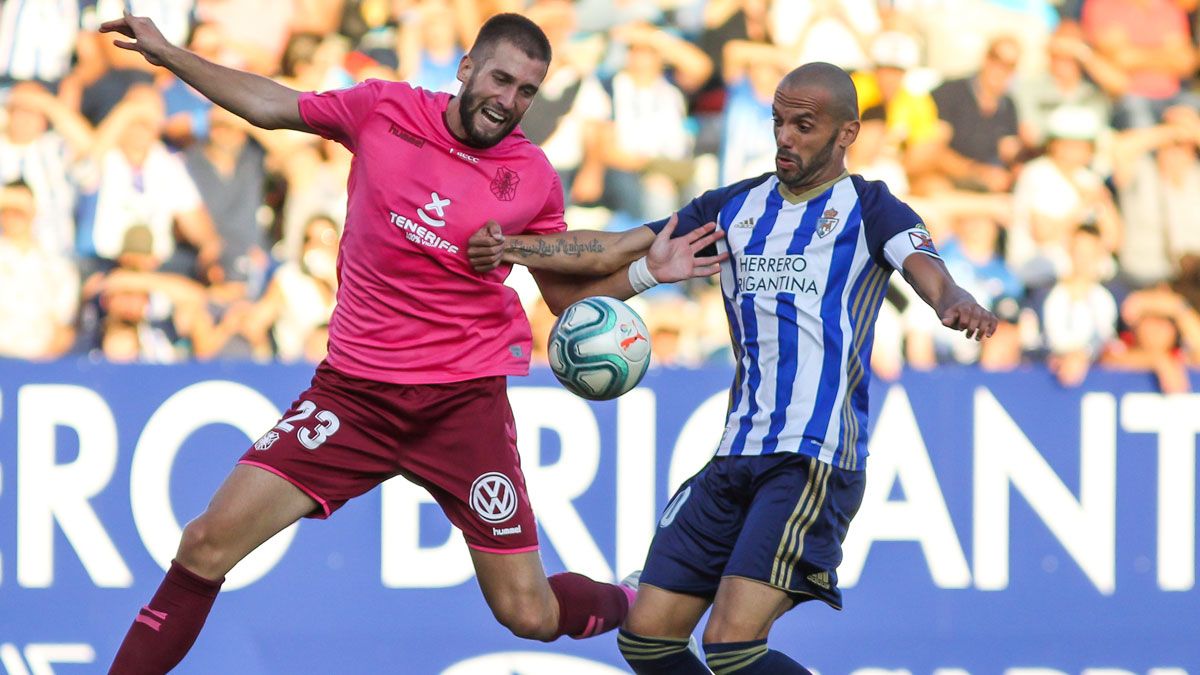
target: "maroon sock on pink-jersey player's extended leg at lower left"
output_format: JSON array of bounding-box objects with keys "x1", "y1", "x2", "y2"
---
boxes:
[{"x1": 108, "y1": 561, "x2": 224, "y2": 675}]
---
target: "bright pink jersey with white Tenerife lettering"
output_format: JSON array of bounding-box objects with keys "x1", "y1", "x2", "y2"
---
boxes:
[{"x1": 300, "y1": 79, "x2": 566, "y2": 384}]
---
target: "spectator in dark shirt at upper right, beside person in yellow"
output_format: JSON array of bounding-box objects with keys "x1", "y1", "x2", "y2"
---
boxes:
[{"x1": 932, "y1": 36, "x2": 1021, "y2": 192}]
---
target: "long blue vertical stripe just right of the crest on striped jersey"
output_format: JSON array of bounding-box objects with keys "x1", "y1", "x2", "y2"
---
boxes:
[{"x1": 804, "y1": 202, "x2": 863, "y2": 455}]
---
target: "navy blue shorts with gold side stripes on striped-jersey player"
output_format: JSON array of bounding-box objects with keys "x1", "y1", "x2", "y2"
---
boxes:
[{"x1": 641, "y1": 453, "x2": 866, "y2": 609}]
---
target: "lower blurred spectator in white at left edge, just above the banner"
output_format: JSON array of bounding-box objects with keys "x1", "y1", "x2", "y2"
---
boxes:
[{"x1": 0, "y1": 180, "x2": 79, "y2": 360}]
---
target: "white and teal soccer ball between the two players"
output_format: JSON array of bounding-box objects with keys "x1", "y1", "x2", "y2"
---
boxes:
[{"x1": 550, "y1": 295, "x2": 650, "y2": 401}]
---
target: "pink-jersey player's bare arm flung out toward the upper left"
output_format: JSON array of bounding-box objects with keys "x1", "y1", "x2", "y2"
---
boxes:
[{"x1": 100, "y1": 12, "x2": 312, "y2": 132}]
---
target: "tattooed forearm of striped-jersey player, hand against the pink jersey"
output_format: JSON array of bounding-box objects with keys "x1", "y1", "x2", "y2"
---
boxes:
[{"x1": 467, "y1": 215, "x2": 721, "y2": 276}]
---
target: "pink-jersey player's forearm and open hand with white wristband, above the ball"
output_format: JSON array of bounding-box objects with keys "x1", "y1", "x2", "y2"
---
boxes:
[{"x1": 530, "y1": 217, "x2": 728, "y2": 316}]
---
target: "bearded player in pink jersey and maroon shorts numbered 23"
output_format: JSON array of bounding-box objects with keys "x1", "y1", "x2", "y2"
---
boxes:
[{"x1": 101, "y1": 14, "x2": 718, "y2": 675}]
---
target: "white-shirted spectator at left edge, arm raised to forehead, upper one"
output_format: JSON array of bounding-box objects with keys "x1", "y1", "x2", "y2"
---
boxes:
[{"x1": 0, "y1": 82, "x2": 92, "y2": 256}]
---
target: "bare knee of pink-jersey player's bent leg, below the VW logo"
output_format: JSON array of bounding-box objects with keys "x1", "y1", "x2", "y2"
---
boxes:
[{"x1": 469, "y1": 548, "x2": 558, "y2": 621}]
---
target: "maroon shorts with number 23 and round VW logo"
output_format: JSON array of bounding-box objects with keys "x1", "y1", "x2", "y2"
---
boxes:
[{"x1": 239, "y1": 364, "x2": 538, "y2": 552}]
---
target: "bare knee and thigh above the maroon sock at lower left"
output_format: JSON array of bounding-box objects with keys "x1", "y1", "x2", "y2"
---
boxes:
[{"x1": 178, "y1": 464, "x2": 317, "y2": 569}]
